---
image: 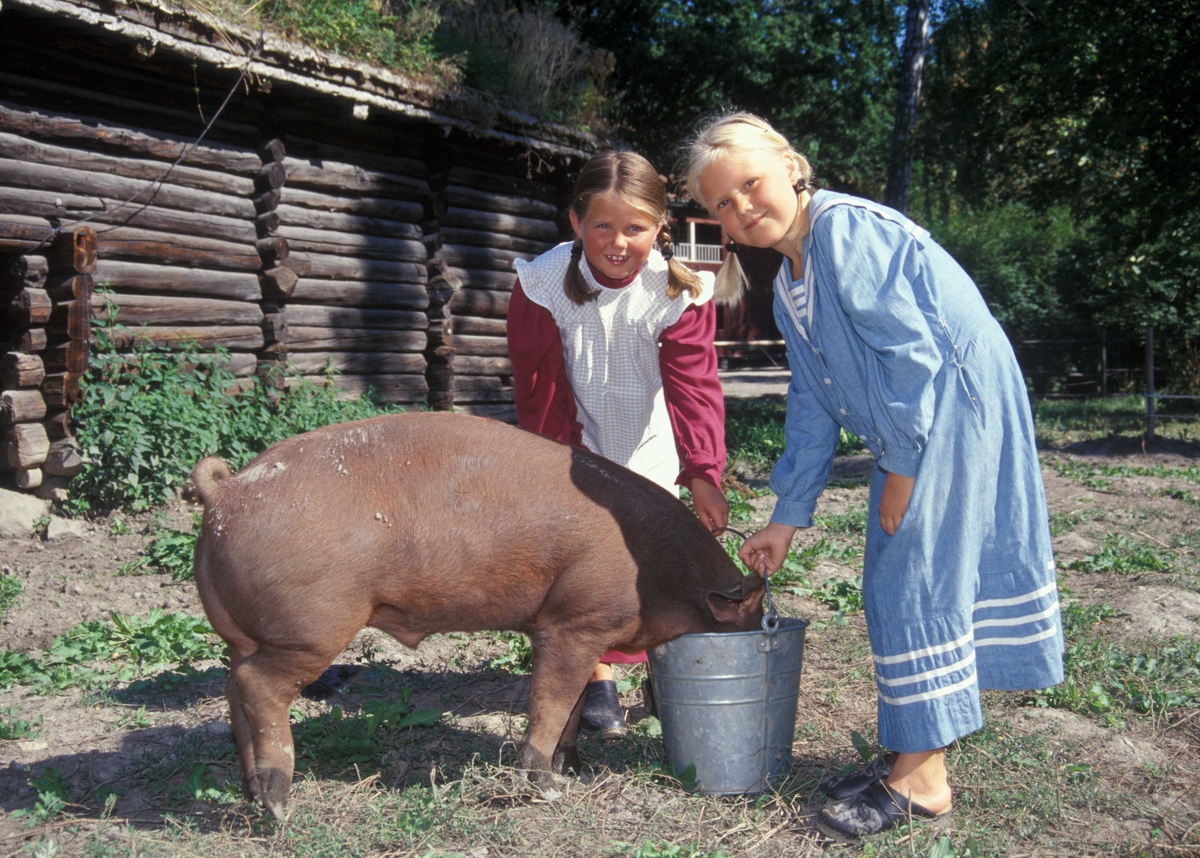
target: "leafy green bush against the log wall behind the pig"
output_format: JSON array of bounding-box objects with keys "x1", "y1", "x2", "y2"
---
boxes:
[{"x1": 68, "y1": 317, "x2": 398, "y2": 514}]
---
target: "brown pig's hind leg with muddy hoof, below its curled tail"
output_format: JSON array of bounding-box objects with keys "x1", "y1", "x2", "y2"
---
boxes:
[{"x1": 226, "y1": 647, "x2": 341, "y2": 820}]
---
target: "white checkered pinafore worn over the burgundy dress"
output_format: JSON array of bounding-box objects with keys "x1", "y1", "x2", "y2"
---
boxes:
[{"x1": 514, "y1": 242, "x2": 713, "y2": 493}]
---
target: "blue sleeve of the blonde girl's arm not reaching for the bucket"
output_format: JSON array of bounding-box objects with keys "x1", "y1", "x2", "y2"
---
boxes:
[{"x1": 812, "y1": 205, "x2": 943, "y2": 476}]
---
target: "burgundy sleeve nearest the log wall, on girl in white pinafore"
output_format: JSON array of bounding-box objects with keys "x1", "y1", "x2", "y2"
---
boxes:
[{"x1": 508, "y1": 280, "x2": 583, "y2": 446}]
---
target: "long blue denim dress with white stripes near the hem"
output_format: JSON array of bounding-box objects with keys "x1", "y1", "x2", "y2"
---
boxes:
[{"x1": 770, "y1": 191, "x2": 1063, "y2": 754}]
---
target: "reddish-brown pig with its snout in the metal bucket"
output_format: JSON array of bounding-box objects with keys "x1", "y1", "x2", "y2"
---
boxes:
[{"x1": 192, "y1": 412, "x2": 766, "y2": 818}]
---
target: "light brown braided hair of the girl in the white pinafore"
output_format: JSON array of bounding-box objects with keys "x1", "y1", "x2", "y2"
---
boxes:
[{"x1": 563, "y1": 151, "x2": 701, "y2": 304}]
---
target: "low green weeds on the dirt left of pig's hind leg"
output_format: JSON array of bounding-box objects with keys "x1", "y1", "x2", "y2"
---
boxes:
[{"x1": 0, "y1": 608, "x2": 224, "y2": 694}]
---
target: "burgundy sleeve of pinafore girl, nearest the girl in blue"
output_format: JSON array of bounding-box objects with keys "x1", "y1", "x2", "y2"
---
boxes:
[{"x1": 659, "y1": 301, "x2": 725, "y2": 487}]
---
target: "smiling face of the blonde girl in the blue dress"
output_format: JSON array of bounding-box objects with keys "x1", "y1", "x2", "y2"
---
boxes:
[{"x1": 700, "y1": 149, "x2": 800, "y2": 253}]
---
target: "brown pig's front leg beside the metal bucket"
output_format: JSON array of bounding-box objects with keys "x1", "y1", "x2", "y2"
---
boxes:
[{"x1": 517, "y1": 630, "x2": 607, "y2": 787}]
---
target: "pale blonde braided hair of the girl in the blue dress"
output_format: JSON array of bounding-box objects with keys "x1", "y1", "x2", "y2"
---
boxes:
[{"x1": 684, "y1": 110, "x2": 812, "y2": 305}]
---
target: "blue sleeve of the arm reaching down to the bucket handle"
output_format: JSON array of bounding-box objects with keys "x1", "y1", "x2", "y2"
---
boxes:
[{"x1": 770, "y1": 301, "x2": 840, "y2": 528}]
